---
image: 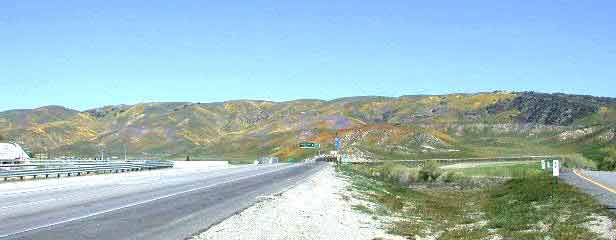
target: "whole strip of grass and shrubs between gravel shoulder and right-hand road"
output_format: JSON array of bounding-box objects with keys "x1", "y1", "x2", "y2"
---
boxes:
[{"x1": 337, "y1": 162, "x2": 616, "y2": 239}]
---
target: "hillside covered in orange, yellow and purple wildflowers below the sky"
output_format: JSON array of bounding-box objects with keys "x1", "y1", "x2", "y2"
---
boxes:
[{"x1": 0, "y1": 92, "x2": 616, "y2": 169}]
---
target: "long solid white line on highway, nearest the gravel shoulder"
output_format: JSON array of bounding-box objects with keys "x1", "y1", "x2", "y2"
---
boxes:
[{"x1": 0, "y1": 165, "x2": 298, "y2": 238}]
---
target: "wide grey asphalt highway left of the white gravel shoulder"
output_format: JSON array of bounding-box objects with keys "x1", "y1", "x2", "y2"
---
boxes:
[{"x1": 0, "y1": 163, "x2": 325, "y2": 240}]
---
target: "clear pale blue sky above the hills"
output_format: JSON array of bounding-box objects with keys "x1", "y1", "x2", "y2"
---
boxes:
[{"x1": 0, "y1": 0, "x2": 616, "y2": 110}]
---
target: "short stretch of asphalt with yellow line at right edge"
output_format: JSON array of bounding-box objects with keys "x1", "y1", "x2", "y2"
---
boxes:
[{"x1": 560, "y1": 170, "x2": 616, "y2": 212}]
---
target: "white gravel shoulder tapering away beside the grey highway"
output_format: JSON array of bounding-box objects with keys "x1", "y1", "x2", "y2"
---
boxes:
[{"x1": 193, "y1": 165, "x2": 404, "y2": 240}]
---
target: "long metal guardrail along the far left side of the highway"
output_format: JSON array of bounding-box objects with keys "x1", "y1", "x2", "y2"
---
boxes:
[{"x1": 0, "y1": 160, "x2": 173, "y2": 181}]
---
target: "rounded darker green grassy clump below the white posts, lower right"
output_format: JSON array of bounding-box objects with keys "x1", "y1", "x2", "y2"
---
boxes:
[{"x1": 483, "y1": 175, "x2": 614, "y2": 239}]
